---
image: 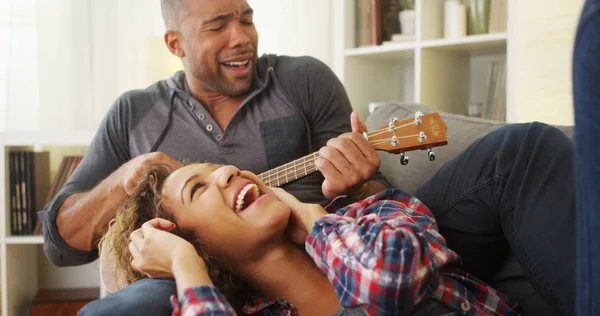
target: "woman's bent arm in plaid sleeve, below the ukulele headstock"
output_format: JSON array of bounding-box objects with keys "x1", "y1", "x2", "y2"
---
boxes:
[{"x1": 306, "y1": 190, "x2": 459, "y2": 314}]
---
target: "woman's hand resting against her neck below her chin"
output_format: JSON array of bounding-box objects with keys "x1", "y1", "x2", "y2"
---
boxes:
[{"x1": 271, "y1": 188, "x2": 327, "y2": 245}]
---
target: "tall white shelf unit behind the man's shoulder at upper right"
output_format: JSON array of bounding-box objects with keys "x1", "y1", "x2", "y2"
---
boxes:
[{"x1": 332, "y1": 0, "x2": 514, "y2": 121}]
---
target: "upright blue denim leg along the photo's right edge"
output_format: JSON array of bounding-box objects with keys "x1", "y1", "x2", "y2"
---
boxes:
[{"x1": 573, "y1": 0, "x2": 600, "y2": 316}]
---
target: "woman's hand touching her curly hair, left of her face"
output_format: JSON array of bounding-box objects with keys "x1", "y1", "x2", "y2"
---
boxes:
[{"x1": 129, "y1": 218, "x2": 206, "y2": 279}]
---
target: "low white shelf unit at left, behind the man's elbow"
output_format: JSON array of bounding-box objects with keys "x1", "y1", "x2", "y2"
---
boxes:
[{"x1": 0, "y1": 131, "x2": 101, "y2": 316}]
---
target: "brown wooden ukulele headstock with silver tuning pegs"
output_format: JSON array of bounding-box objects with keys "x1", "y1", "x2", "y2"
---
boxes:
[{"x1": 367, "y1": 112, "x2": 448, "y2": 160}]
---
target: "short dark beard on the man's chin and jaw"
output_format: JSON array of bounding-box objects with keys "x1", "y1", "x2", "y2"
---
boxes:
[{"x1": 193, "y1": 60, "x2": 255, "y2": 97}]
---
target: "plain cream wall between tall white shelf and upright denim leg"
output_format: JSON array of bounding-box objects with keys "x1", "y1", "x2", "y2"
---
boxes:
[{"x1": 508, "y1": 0, "x2": 584, "y2": 125}]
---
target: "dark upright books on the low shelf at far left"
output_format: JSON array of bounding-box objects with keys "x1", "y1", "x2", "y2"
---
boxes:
[{"x1": 8, "y1": 151, "x2": 50, "y2": 236}]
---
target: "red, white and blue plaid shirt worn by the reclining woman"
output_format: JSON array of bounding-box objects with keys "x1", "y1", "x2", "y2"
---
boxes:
[{"x1": 172, "y1": 189, "x2": 520, "y2": 316}]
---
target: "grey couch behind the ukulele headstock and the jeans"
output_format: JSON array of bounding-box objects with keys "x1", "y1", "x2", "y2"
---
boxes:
[{"x1": 365, "y1": 102, "x2": 573, "y2": 315}]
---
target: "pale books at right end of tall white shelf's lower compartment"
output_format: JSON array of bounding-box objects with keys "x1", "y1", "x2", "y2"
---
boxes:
[{"x1": 482, "y1": 61, "x2": 506, "y2": 121}]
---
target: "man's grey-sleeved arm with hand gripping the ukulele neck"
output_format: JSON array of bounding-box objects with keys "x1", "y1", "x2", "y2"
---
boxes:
[{"x1": 279, "y1": 57, "x2": 390, "y2": 200}]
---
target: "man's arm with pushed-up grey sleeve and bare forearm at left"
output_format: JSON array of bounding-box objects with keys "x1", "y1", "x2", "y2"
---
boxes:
[{"x1": 39, "y1": 102, "x2": 130, "y2": 266}]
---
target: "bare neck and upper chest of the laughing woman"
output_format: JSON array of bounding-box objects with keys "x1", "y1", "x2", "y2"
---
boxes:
[{"x1": 234, "y1": 240, "x2": 340, "y2": 315}]
